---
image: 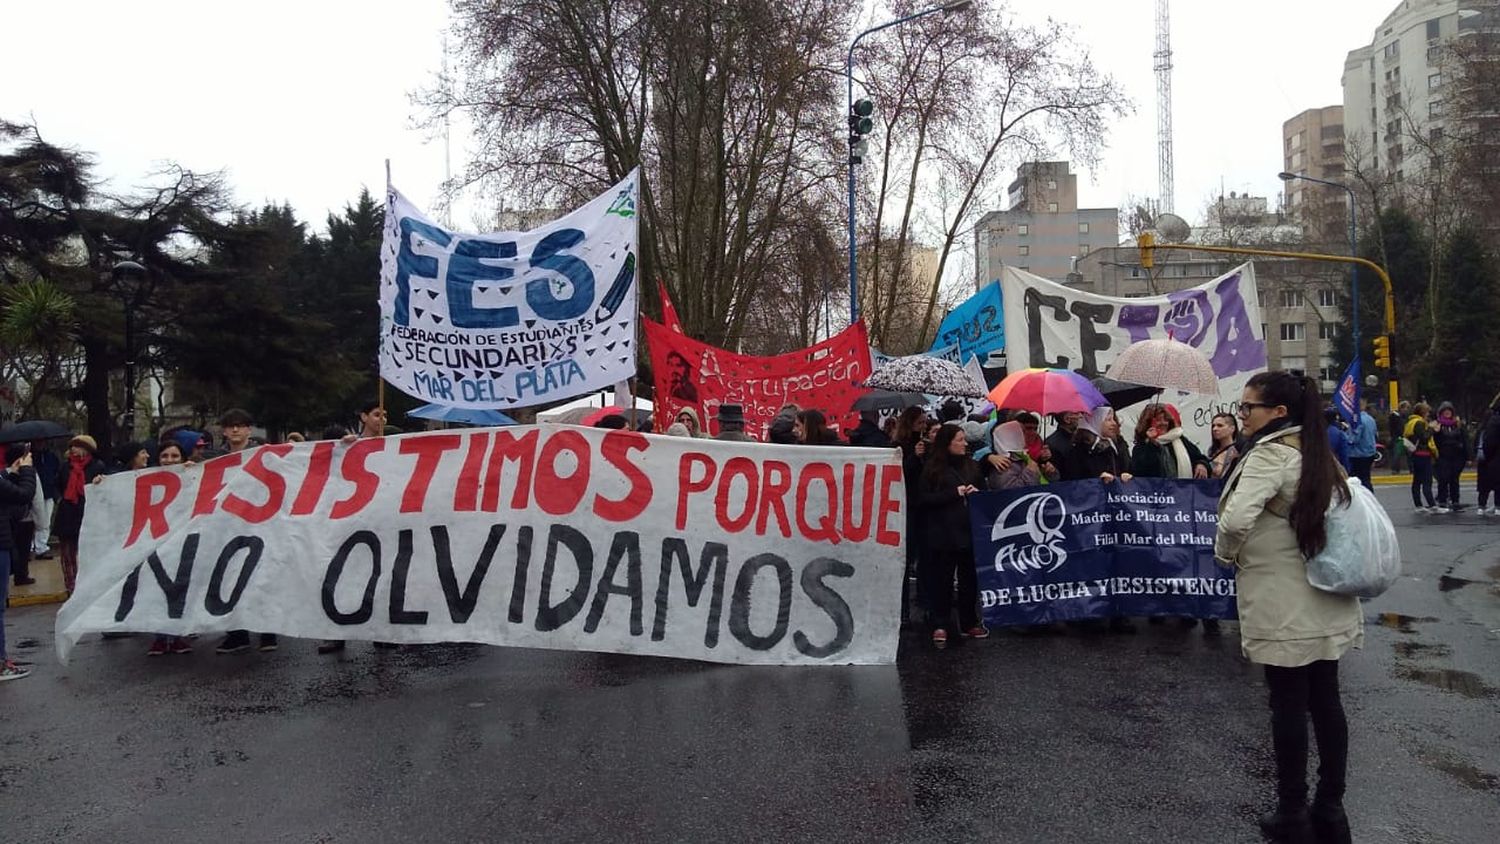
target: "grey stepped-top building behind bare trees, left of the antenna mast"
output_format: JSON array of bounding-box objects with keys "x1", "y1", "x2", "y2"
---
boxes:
[{"x1": 974, "y1": 162, "x2": 1119, "y2": 288}]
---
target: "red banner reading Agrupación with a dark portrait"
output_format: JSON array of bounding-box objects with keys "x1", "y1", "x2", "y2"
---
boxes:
[{"x1": 642, "y1": 319, "x2": 870, "y2": 441}]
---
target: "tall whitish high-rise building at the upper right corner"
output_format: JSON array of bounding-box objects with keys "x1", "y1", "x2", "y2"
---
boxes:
[{"x1": 1343, "y1": 0, "x2": 1470, "y2": 181}]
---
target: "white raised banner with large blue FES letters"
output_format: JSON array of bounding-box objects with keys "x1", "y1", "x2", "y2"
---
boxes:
[{"x1": 380, "y1": 172, "x2": 638, "y2": 408}]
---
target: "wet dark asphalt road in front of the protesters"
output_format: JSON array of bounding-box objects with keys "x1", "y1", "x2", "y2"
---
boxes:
[{"x1": 0, "y1": 487, "x2": 1500, "y2": 844}]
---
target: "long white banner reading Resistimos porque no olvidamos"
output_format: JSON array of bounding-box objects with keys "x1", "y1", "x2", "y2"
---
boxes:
[{"x1": 57, "y1": 426, "x2": 906, "y2": 664}]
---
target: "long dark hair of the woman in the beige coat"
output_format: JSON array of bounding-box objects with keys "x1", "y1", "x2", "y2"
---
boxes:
[{"x1": 1245, "y1": 370, "x2": 1349, "y2": 558}]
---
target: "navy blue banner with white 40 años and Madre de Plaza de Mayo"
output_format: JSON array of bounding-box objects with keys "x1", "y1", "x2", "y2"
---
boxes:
[{"x1": 969, "y1": 478, "x2": 1238, "y2": 625}]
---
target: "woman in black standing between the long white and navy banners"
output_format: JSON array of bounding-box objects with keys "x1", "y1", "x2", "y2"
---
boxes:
[{"x1": 917, "y1": 423, "x2": 990, "y2": 648}]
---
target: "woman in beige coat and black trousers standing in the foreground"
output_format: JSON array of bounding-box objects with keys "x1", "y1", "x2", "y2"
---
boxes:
[{"x1": 1214, "y1": 372, "x2": 1364, "y2": 841}]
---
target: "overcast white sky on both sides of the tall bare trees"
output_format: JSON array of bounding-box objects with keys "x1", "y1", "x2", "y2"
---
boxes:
[{"x1": 0, "y1": 0, "x2": 1395, "y2": 228}]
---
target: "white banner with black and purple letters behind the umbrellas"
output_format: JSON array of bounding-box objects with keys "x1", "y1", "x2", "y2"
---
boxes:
[{"x1": 1001, "y1": 264, "x2": 1266, "y2": 453}]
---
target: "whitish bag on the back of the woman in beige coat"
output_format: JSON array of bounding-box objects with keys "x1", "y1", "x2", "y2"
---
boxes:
[{"x1": 1307, "y1": 478, "x2": 1401, "y2": 598}]
